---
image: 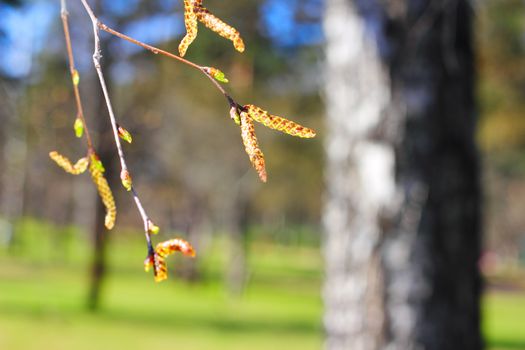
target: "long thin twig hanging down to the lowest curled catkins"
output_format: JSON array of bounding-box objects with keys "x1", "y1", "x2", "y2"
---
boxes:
[{"x1": 81, "y1": 0, "x2": 155, "y2": 258}]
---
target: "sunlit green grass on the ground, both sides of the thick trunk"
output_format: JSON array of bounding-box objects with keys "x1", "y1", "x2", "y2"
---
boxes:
[{"x1": 0, "y1": 223, "x2": 525, "y2": 350}]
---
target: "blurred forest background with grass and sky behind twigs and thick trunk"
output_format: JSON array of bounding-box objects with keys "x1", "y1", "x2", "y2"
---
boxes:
[{"x1": 0, "y1": 0, "x2": 525, "y2": 349}]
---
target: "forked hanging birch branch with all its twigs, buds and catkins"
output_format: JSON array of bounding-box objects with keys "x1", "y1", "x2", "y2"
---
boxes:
[{"x1": 50, "y1": 0, "x2": 315, "y2": 281}]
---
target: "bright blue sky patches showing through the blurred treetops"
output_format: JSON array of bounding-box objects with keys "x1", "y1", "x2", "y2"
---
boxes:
[{"x1": 0, "y1": 0, "x2": 323, "y2": 78}]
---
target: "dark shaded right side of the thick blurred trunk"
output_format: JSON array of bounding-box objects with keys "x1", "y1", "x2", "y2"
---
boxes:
[{"x1": 385, "y1": 1, "x2": 482, "y2": 350}]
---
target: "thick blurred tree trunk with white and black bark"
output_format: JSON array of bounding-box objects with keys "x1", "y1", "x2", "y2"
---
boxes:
[{"x1": 323, "y1": 0, "x2": 483, "y2": 350}]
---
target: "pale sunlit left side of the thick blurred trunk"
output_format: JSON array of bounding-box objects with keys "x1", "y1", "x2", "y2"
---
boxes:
[{"x1": 323, "y1": 0, "x2": 394, "y2": 350}]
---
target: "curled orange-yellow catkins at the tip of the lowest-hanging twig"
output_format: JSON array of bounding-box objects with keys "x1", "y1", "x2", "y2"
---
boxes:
[{"x1": 151, "y1": 238, "x2": 195, "y2": 282}]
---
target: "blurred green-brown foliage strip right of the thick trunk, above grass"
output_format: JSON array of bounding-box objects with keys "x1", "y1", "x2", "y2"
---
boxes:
[{"x1": 475, "y1": 0, "x2": 525, "y2": 265}]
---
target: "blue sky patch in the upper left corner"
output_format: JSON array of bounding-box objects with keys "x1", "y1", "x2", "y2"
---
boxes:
[{"x1": 0, "y1": 1, "x2": 59, "y2": 78}]
